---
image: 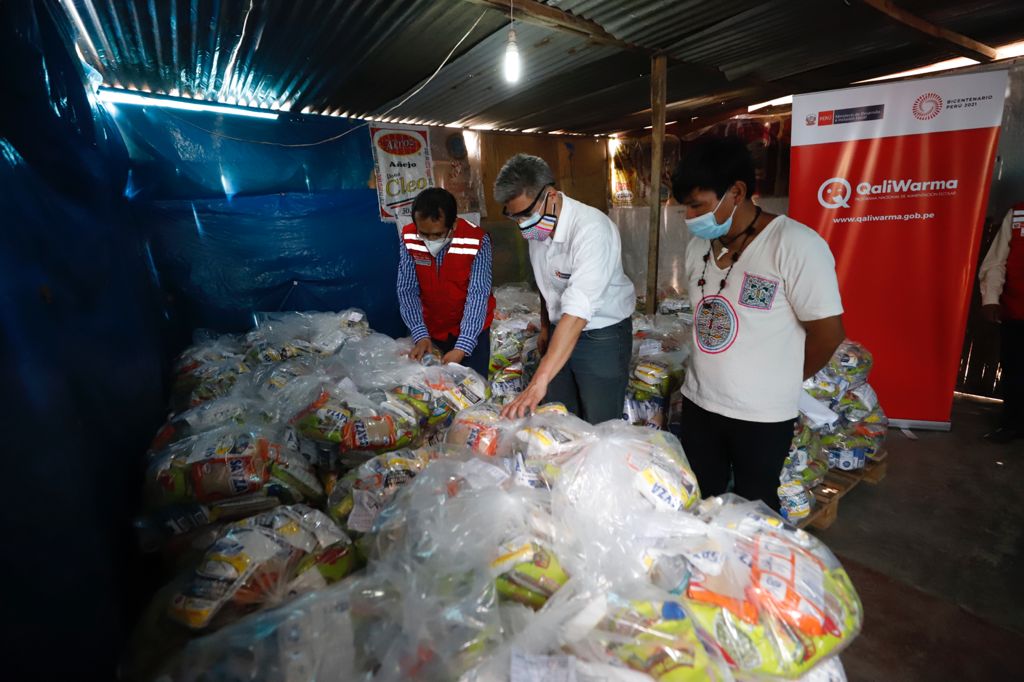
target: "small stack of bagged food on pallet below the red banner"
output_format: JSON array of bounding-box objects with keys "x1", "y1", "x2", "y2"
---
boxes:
[{"x1": 778, "y1": 340, "x2": 889, "y2": 521}]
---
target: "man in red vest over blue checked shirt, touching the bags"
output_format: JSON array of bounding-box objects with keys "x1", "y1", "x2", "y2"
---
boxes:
[{"x1": 397, "y1": 187, "x2": 495, "y2": 378}]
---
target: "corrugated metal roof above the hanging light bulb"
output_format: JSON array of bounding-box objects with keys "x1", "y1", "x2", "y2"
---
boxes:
[{"x1": 59, "y1": 0, "x2": 1024, "y2": 133}]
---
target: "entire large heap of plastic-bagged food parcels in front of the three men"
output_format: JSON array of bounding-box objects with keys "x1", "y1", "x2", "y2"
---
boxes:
[{"x1": 143, "y1": 313, "x2": 862, "y2": 681}]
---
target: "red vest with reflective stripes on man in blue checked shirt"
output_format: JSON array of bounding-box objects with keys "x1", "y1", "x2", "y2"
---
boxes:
[{"x1": 401, "y1": 218, "x2": 495, "y2": 341}]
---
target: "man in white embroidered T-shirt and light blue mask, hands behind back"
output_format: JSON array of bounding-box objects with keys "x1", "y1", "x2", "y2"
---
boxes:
[{"x1": 672, "y1": 138, "x2": 845, "y2": 510}]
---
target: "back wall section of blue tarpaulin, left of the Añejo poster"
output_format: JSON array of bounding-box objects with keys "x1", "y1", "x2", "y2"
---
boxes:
[{"x1": 111, "y1": 95, "x2": 407, "y2": 345}]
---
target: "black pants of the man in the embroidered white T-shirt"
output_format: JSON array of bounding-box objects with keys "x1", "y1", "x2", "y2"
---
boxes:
[{"x1": 676, "y1": 398, "x2": 796, "y2": 511}]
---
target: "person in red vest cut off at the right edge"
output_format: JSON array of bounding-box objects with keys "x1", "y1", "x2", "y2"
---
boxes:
[{"x1": 978, "y1": 202, "x2": 1024, "y2": 442}]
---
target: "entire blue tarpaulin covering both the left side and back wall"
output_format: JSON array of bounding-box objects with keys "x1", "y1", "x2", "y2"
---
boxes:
[{"x1": 0, "y1": 0, "x2": 406, "y2": 680}]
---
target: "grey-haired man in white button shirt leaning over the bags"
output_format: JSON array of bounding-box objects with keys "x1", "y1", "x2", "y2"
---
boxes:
[{"x1": 495, "y1": 154, "x2": 636, "y2": 424}]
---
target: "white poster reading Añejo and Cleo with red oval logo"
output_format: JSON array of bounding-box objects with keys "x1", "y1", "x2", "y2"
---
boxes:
[{"x1": 370, "y1": 126, "x2": 434, "y2": 222}]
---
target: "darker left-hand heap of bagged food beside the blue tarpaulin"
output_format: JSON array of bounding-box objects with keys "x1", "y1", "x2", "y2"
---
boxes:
[{"x1": 130, "y1": 310, "x2": 497, "y2": 667}]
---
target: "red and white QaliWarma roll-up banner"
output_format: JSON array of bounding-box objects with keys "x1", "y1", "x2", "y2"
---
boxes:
[{"x1": 790, "y1": 71, "x2": 1008, "y2": 426}]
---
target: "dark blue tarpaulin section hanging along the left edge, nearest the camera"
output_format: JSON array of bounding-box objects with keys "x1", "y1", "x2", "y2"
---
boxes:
[{"x1": 0, "y1": 0, "x2": 166, "y2": 680}]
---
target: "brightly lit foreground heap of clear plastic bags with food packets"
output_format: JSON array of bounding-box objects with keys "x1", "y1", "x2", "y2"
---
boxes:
[{"x1": 161, "y1": 403, "x2": 862, "y2": 682}]
